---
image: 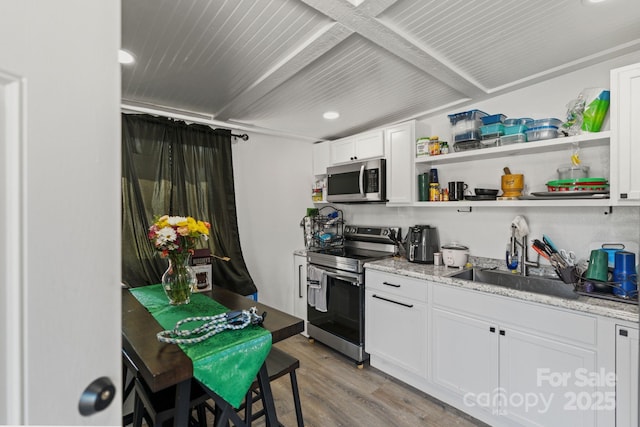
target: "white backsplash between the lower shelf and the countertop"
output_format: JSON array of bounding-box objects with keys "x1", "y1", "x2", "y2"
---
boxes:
[{"x1": 332, "y1": 203, "x2": 640, "y2": 270}]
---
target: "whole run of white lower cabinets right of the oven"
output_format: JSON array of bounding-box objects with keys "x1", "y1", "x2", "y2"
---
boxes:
[{"x1": 365, "y1": 269, "x2": 620, "y2": 427}]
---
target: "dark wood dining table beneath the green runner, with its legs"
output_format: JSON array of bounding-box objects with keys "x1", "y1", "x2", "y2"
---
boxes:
[{"x1": 122, "y1": 286, "x2": 304, "y2": 426}]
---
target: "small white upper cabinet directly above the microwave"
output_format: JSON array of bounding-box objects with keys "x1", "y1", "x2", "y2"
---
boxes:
[{"x1": 329, "y1": 130, "x2": 384, "y2": 165}]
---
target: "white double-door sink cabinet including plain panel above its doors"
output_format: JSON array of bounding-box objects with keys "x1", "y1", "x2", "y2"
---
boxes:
[{"x1": 431, "y1": 284, "x2": 600, "y2": 426}]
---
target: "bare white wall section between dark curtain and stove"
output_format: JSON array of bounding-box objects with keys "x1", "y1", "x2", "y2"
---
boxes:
[{"x1": 233, "y1": 134, "x2": 313, "y2": 312}]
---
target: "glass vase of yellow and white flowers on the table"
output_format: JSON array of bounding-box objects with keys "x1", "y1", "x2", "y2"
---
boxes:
[{"x1": 149, "y1": 215, "x2": 211, "y2": 305}]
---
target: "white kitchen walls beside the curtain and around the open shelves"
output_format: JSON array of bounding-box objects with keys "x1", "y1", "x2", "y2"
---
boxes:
[{"x1": 234, "y1": 52, "x2": 640, "y2": 310}]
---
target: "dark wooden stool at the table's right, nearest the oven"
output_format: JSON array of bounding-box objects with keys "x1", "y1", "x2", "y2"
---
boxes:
[{"x1": 239, "y1": 347, "x2": 304, "y2": 427}]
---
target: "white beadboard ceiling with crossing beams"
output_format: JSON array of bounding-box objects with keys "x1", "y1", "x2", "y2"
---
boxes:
[{"x1": 122, "y1": 0, "x2": 640, "y2": 140}]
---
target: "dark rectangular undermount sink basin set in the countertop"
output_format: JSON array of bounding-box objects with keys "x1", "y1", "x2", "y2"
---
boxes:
[{"x1": 451, "y1": 268, "x2": 578, "y2": 299}]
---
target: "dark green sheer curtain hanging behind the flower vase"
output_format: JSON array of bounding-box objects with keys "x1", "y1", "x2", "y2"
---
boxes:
[{"x1": 122, "y1": 114, "x2": 256, "y2": 295}]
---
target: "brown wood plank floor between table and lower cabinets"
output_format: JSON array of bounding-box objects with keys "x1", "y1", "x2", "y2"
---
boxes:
[{"x1": 245, "y1": 335, "x2": 485, "y2": 427}]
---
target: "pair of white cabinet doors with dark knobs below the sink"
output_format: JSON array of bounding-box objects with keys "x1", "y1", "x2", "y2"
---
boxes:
[{"x1": 432, "y1": 309, "x2": 596, "y2": 426}]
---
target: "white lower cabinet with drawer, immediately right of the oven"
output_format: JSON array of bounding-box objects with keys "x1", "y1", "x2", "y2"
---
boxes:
[{"x1": 365, "y1": 272, "x2": 427, "y2": 378}]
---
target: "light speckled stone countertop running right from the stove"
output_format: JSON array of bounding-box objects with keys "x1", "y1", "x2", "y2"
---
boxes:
[{"x1": 364, "y1": 257, "x2": 638, "y2": 323}]
